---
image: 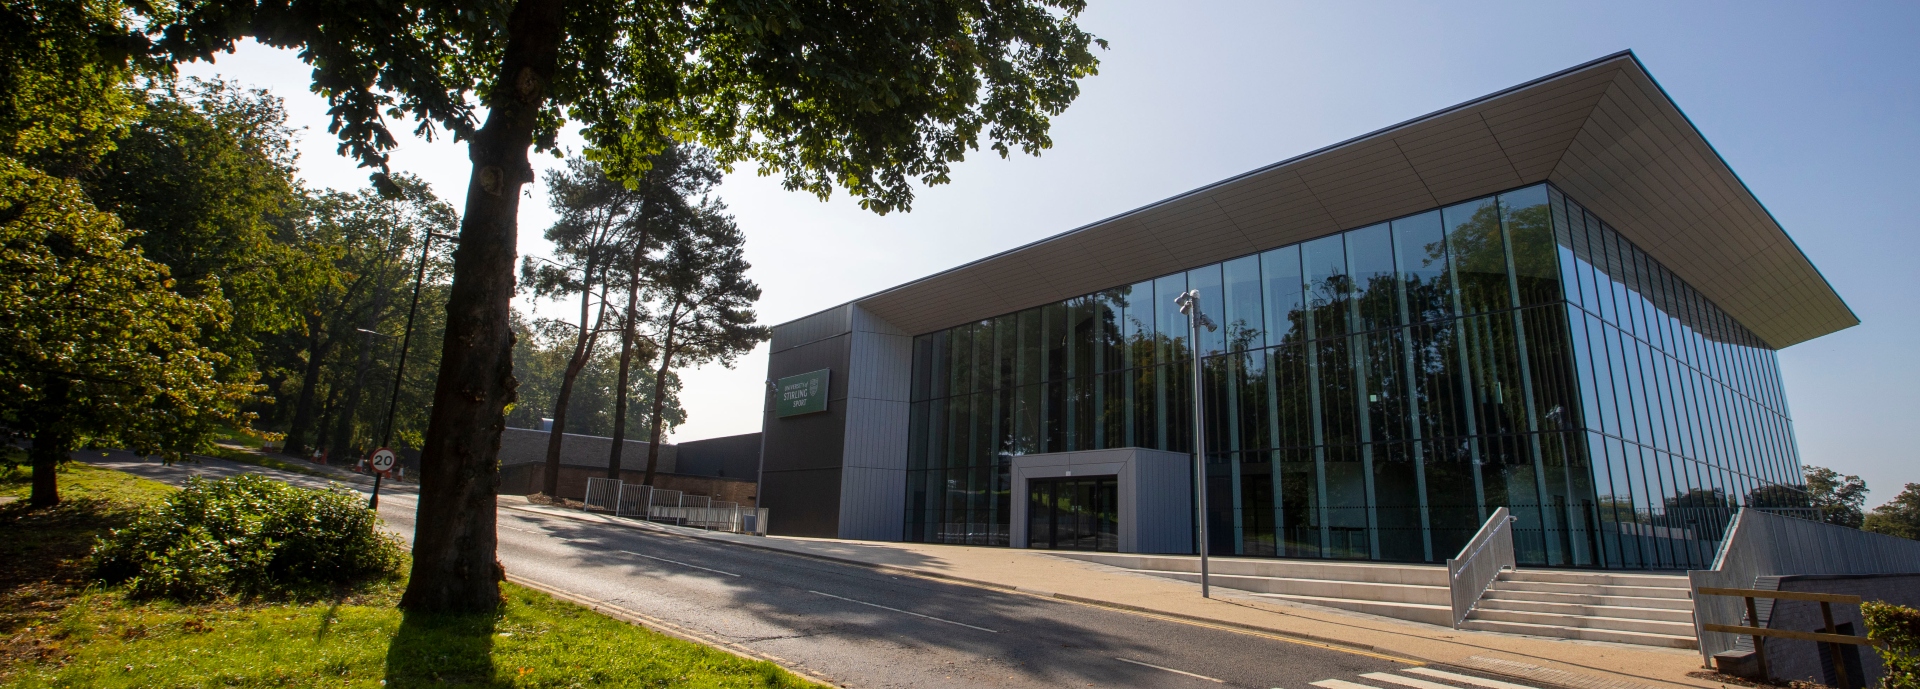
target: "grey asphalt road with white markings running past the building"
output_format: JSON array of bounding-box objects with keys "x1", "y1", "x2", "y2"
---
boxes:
[{"x1": 86, "y1": 457, "x2": 1559, "y2": 689}]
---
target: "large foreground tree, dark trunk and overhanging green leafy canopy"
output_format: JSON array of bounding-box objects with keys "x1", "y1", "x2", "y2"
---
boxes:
[{"x1": 131, "y1": 0, "x2": 1096, "y2": 610}]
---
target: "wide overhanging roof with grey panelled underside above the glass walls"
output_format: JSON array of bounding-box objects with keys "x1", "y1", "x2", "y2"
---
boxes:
[{"x1": 776, "y1": 52, "x2": 1859, "y2": 349}]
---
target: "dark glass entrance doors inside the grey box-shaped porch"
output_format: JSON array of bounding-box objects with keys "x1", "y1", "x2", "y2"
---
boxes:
[{"x1": 1027, "y1": 476, "x2": 1119, "y2": 553}]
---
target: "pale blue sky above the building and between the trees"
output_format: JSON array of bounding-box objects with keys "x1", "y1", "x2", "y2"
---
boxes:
[{"x1": 186, "y1": 0, "x2": 1920, "y2": 505}]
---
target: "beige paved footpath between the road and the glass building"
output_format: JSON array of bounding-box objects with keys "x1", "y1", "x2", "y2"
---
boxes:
[{"x1": 501, "y1": 495, "x2": 1722, "y2": 689}]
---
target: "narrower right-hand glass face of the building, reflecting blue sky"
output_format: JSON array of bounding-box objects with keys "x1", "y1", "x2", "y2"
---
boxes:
[{"x1": 1551, "y1": 190, "x2": 1809, "y2": 568}]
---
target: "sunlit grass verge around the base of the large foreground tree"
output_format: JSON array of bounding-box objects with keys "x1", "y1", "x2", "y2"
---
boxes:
[{"x1": 0, "y1": 464, "x2": 812, "y2": 687}]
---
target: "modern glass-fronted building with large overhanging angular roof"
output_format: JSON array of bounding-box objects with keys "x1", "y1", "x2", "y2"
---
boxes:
[{"x1": 760, "y1": 52, "x2": 1859, "y2": 568}]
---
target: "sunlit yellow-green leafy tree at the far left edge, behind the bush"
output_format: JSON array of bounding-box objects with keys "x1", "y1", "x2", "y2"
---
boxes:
[{"x1": 0, "y1": 157, "x2": 253, "y2": 505}]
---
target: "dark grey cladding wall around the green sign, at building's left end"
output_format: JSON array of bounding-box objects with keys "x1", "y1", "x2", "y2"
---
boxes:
[{"x1": 760, "y1": 307, "x2": 852, "y2": 537}]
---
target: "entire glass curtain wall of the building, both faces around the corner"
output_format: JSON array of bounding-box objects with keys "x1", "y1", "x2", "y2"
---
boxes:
[{"x1": 904, "y1": 184, "x2": 1799, "y2": 568}]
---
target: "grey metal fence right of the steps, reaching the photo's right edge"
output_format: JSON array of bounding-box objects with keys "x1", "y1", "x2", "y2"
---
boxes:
[{"x1": 1688, "y1": 509, "x2": 1920, "y2": 664}]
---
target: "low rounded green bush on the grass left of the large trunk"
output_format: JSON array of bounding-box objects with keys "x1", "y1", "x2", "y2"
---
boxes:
[{"x1": 92, "y1": 476, "x2": 405, "y2": 601}]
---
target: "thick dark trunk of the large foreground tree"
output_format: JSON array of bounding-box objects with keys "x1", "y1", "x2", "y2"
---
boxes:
[{"x1": 399, "y1": 0, "x2": 564, "y2": 612}]
